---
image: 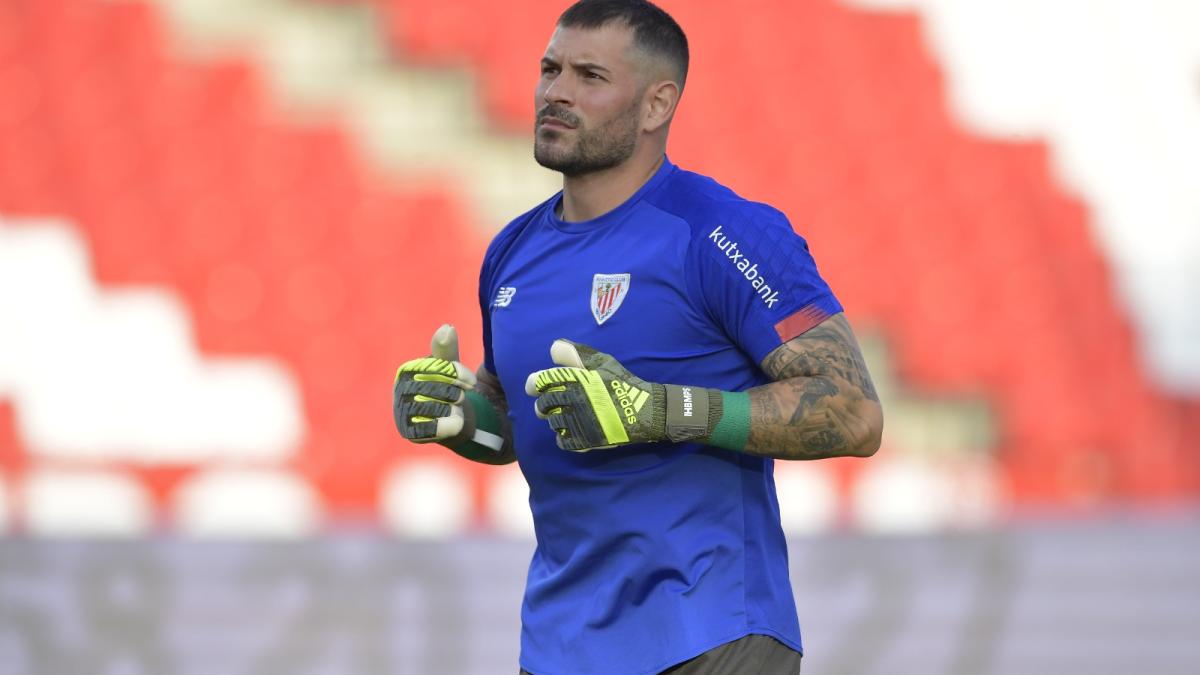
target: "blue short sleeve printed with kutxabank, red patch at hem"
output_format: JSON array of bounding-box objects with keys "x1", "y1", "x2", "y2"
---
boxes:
[{"x1": 686, "y1": 203, "x2": 842, "y2": 363}]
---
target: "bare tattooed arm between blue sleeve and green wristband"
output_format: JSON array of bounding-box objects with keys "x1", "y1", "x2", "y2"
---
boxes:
[{"x1": 745, "y1": 313, "x2": 883, "y2": 459}]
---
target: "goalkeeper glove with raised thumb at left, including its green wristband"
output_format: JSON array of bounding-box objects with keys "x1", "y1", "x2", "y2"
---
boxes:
[{"x1": 391, "y1": 324, "x2": 504, "y2": 461}]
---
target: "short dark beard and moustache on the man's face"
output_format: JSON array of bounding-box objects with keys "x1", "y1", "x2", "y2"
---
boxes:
[{"x1": 533, "y1": 98, "x2": 640, "y2": 178}]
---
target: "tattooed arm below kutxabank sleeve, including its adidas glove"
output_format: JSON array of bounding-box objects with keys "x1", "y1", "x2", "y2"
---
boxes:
[{"x1": 520, "y1": 313, "x2": 883, "y2": 459}]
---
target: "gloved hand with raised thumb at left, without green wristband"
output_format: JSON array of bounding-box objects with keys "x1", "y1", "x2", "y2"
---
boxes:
[{"x1": 391, "y1": 323, "x2": 475, "y2": 444}]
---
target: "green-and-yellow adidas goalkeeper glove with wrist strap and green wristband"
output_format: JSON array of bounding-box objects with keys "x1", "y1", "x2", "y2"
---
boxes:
[{"x1": 526, "y1": 340, "x2": 750, "y2": 452}]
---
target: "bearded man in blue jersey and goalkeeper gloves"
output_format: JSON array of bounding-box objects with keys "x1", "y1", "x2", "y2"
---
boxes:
[{"x1": 394, "y1": 0, "x2": 883, "y2": 675}]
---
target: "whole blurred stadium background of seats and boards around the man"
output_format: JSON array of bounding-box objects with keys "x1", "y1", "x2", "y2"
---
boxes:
[{"x1": 0, "y1": 0, "x2": 1200, "y2": 675}]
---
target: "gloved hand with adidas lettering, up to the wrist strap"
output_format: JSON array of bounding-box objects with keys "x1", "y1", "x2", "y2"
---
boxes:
[{"x1": 526, "y1": 340, "x2": 667, "y2": 452}]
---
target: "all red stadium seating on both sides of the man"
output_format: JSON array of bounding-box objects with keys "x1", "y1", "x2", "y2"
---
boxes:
[{"x1": 0, "y1": 0, "x2": 1200, "y2": 540}]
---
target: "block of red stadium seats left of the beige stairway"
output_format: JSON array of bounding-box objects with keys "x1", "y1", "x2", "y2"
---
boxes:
[{"x1": 0, "y1": 0, "x2": 485, "y2": 526}]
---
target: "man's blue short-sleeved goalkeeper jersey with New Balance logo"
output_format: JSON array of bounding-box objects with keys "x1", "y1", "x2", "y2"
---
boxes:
[{"x1": 480, "y1": 160, "x2": 841, "y2": 675}]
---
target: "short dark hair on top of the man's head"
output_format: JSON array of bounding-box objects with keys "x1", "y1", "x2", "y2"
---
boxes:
[{"x1": 558, "y1": 0, "x2": 688, "y2": 88}]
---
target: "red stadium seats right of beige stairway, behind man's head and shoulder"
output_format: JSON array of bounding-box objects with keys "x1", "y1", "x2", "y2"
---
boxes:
[{"x1": 377, "y1": 0, "x2": 1198, "y2": 502}]
